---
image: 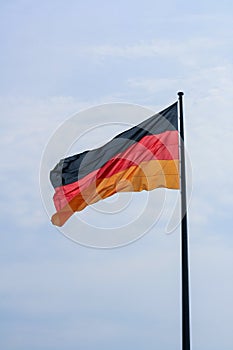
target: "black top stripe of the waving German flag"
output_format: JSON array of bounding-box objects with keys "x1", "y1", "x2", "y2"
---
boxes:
[{"x1": 50, "y1": 102, "x2": 178, "y2": 188}]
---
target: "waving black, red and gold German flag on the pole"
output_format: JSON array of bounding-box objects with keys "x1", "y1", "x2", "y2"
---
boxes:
[{"x1": 50, "y1": 102, "x2": 179, "y2": 226}]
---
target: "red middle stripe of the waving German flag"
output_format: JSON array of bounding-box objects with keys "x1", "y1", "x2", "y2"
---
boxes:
[{"x1": 53, "y1": 131, "x2": 179, "y2": 210}]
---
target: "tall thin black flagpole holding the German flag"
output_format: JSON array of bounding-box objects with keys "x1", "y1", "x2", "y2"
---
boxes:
[{"x1": 178, "y1": 92, "x2": 190, "y2": 350}]
